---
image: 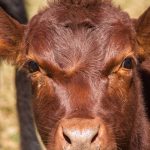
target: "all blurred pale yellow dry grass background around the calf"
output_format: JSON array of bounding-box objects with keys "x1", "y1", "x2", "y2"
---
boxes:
[{"x1": 0, "y1": 0, "x2": 150, "y2": 150}]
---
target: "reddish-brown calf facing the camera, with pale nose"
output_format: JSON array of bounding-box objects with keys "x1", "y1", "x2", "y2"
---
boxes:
[{"x1": 0, "y1": 0, "x2": 150, "y2": 150}]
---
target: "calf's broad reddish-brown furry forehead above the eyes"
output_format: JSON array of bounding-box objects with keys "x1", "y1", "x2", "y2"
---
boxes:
[{"x1": 27, "y1": 3, "x2": 134, "y2": 68}]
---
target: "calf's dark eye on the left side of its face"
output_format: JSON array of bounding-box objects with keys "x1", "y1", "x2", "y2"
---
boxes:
[{"x1": 27, "y1": 60, "x2": 40, "y2": 73}]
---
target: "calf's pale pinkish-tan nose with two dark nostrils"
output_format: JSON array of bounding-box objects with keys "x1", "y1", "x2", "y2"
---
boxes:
[{"x1": 60, "y1": 118, "x2": 100, "y2": 150}]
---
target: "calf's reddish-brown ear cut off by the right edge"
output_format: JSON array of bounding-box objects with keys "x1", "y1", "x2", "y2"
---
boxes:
[{"x1": 136, "y1": 7, "x2": 150, "y2": 58}]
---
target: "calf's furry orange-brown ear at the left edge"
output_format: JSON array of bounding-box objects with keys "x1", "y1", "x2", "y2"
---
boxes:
[{"x1": 0, "y1": 8, "x2": 25, "y2": 63}]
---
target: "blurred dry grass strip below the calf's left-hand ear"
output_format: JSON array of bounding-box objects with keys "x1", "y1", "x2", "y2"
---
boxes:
[{"x1": 0, "y1": 63, "x2": 19, "y2": 150}]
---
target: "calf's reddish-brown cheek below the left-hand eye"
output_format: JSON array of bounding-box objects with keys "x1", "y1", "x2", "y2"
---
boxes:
[{"x1": 32, "y1": 78, "x2": 60, "y2": 145}]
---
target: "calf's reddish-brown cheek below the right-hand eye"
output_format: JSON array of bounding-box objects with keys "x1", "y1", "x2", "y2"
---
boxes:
[{"x1": 108, "y1": 75, "x2": 137, "y2": 140}]
